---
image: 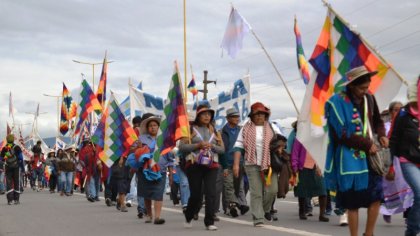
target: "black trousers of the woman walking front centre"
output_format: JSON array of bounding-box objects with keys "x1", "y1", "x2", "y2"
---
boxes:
[{"x1": 185, "y1": 164, "x2": 218, "y2": 226}]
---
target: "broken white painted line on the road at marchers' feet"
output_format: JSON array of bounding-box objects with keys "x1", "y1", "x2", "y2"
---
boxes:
[{"x1": 74, "y1": 193, "x2": 331, "y2": 236}]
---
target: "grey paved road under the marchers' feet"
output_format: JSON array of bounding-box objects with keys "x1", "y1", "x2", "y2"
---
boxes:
[{"x1": 0, "y1": 189, "x2": 404, "y2": 236}]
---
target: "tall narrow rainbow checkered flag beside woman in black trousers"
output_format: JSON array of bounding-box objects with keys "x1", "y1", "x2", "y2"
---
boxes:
[{"x1": 151, "y1": 61, "x2": 190, "y2": 166}]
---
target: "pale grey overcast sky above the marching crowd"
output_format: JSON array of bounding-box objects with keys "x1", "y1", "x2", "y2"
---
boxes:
[{"x1": 0, "y1": 0, "x2": 420, "y2": 137}]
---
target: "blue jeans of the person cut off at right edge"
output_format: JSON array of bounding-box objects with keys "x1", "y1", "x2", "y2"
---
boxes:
[{"x1": 401, "y1": 163, "x2": 420, "y2": 236}]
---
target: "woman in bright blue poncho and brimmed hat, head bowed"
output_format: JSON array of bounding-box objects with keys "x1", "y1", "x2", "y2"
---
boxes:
[{"x1": 325, "y1": 66, "x2": 388, "y2": 236}]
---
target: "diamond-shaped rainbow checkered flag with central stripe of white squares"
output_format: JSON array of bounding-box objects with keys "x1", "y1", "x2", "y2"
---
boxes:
[{"x1": 92, "y1": 93, "x2": 137, "y2": 167}]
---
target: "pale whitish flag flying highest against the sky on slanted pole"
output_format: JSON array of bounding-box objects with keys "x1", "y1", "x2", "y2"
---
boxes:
[{"x1": 220, "y1": 7, "x2": 252, "y2": 58}]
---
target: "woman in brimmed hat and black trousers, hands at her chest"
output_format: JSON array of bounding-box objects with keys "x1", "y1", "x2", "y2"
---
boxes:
[{"x1": 179, "y1": 105, "x2": 225, "y2": 231}]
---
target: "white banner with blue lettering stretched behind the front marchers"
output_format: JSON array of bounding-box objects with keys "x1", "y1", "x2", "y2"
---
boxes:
[{"x1": 130, "y1": 75, "x2": 251, "y2": 129}]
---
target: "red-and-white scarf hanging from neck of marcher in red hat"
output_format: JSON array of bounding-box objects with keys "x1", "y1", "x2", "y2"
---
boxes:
[{"x1": 243, "y1": 121, "x2": 274, "y2": 170}]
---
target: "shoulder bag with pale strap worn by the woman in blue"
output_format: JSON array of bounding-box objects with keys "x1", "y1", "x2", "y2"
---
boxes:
[{"x1": 364, "y1": 97, "x2": 391, "y2": 176}]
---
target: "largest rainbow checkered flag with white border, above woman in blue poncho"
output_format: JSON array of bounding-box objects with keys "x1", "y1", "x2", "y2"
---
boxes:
[{"x1": 297, "y1": 9, "x2": 402, "y2": 168}]
